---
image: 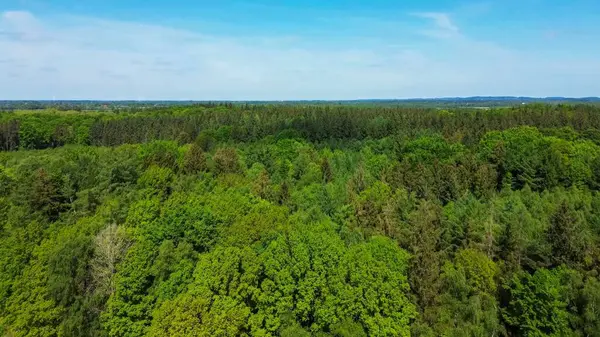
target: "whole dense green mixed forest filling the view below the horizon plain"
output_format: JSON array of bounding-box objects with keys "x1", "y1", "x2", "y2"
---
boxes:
[{"x1": 0, "y1": 103, "x2": 600, "y2": 337}]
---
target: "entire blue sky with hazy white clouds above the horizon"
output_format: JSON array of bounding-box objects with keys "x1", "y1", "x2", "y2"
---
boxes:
[{"x1": 0, "y1": 0, "x2": 600, "y2": 100}]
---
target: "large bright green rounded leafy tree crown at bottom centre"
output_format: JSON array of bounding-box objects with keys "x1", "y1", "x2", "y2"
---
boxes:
[{"x1": 148, "y1": 224, "x2": 415, "y2": 336}]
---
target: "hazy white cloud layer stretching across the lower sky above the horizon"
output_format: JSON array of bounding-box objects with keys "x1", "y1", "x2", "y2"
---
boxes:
[{"x1": 0, "y1": 8, "x2": 600, "y2": 100}]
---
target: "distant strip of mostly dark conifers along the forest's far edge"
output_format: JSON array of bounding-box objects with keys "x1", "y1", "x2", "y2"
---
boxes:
[{"x1": 0, "y1": 104, "x2": 600, "y2": 151}]
